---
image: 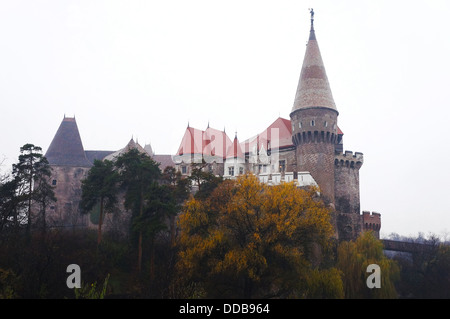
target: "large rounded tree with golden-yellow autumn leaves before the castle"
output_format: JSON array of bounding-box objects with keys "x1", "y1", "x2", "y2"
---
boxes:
[{"x1": 178, "y1": 174, "x2": 342, "y2": 298}]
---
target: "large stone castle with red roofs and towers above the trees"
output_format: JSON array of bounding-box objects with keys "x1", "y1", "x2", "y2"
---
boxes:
[{"x1": 41, "y1": 11, "x2": 381, "y2": 240}]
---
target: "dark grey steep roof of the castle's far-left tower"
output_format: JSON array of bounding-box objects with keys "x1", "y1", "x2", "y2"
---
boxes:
[{"x1": 45, "y1": 117, "x2": 92, "y2": 167}]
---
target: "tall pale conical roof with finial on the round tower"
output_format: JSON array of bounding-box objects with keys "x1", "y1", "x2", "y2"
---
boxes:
[{"x1": 292, "y1": 10, "x2": 337, "y2": 112}]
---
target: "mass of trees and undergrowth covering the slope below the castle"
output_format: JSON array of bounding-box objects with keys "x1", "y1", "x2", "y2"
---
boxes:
[{"x1": 0, "y1": 144, "x2": 450, "y2": 299}]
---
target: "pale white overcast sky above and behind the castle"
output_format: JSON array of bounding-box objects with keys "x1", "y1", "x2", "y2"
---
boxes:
[{"x1": 0, "y1": 0, "x2": 450, "y2": 240}]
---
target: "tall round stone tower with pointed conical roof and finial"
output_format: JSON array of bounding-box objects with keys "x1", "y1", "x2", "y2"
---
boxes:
[{"x1": 290, "y1": 10, "x2": 339, "y2": 205}]
